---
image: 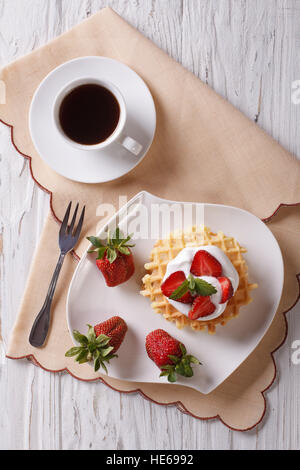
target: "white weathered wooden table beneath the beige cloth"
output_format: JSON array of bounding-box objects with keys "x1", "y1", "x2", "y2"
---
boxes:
[{"x1": 0, "y1": 0, "x2": 300, "y2": 450}]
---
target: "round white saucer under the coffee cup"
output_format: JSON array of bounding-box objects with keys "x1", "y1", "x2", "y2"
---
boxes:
[{"x1": 29, "y1": 57, "x2": 156, "y2": 183}]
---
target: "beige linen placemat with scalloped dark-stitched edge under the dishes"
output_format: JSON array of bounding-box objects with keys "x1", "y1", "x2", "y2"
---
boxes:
[{"x1": 0, "y1": 8, "x2": 300, "y2": 430}]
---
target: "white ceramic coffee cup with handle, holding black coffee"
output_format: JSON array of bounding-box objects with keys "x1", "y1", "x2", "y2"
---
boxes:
[{"x1": 53, "y1": 78, "x2": 143, "y2": 156}]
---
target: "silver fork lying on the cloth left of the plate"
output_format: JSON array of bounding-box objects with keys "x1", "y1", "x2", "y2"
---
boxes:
[{"x1": 29, "y1": 202, "x2": 85, "y2": 348}]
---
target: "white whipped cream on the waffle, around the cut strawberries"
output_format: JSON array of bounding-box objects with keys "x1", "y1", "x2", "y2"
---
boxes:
[{"x1": 163, "y1": 245, "x2": 239, "y2": 321}]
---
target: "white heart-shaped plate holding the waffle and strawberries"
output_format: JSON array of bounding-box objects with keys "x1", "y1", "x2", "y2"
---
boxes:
[{"x1": 67, "y1": 191, "x2": 284, "y2": 394}]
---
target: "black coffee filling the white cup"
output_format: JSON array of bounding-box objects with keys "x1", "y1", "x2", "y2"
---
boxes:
[{"x1": 59, "y1": 83, "x2": 120, "y2": 145}]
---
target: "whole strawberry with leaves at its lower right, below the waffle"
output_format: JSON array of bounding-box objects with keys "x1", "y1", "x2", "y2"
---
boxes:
[{"x1": 146, "y1": 329, "x2": 200, "y2": 382}]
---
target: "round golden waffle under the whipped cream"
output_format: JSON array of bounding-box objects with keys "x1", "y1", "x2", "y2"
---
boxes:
[{"x1": 141, "y1": 226, "x2": 257, "y2": 334}]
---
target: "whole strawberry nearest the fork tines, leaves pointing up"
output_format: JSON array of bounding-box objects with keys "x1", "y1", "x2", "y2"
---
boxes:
[{"x1": 87, "y1": 228, "x2": 134, "y2": 287}]
